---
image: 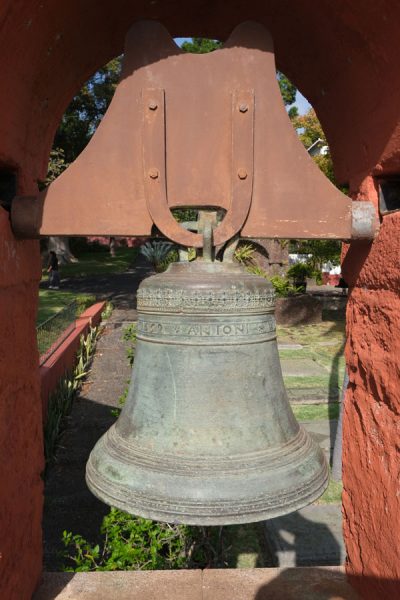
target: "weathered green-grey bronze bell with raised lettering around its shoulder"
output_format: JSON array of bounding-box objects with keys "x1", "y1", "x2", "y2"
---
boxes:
[{"x1": 86, "y1": 239, "x2": 328, "y2": 525}]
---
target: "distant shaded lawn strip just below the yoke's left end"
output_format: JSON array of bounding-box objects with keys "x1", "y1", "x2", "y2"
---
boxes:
[{"x1": 43, "y1": 248, "x2": 139, "y2": 279}]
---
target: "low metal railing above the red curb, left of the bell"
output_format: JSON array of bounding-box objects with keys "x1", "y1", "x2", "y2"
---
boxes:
[{"x1": 36, "y1": 300, "x2": 78, "y2": 365}]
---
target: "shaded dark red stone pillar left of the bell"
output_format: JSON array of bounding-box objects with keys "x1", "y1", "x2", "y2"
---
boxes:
[{"x1": 0, "y1": 207, "x2": 44, "y2": 600}]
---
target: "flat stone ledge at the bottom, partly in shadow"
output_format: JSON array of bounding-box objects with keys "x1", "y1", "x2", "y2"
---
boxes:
[{"x1": 33, "y1": 567, "x2": 358, "y2": 600}]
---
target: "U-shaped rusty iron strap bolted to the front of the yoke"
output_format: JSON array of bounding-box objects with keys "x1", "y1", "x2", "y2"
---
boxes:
[{"x1": 142, "y1": 89, "x2": 254, "y2": 248}]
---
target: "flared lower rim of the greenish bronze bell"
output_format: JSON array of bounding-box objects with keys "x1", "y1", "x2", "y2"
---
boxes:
[{"x1": 86, "y1": 422, "x2": 329, "y2": 525}]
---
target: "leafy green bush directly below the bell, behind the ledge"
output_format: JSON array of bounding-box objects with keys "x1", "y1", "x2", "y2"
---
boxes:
[{"x1": 62, "y1": 508, "x2": 234, "y2": 571}]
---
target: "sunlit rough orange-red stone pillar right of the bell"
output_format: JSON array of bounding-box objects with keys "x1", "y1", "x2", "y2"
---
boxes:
[{"x1": 343, "y1": 177, "x2": 400, "y2": 600}]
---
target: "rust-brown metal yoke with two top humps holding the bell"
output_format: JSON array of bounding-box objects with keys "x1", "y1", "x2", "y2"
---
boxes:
[{"x1": 11, "y1": 21, "x2": 377, "y2": 247}]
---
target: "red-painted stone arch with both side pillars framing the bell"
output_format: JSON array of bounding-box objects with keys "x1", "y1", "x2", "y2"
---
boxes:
[{"x1": 0, "y1": 0, "x2": 400, "y2": 600}]
